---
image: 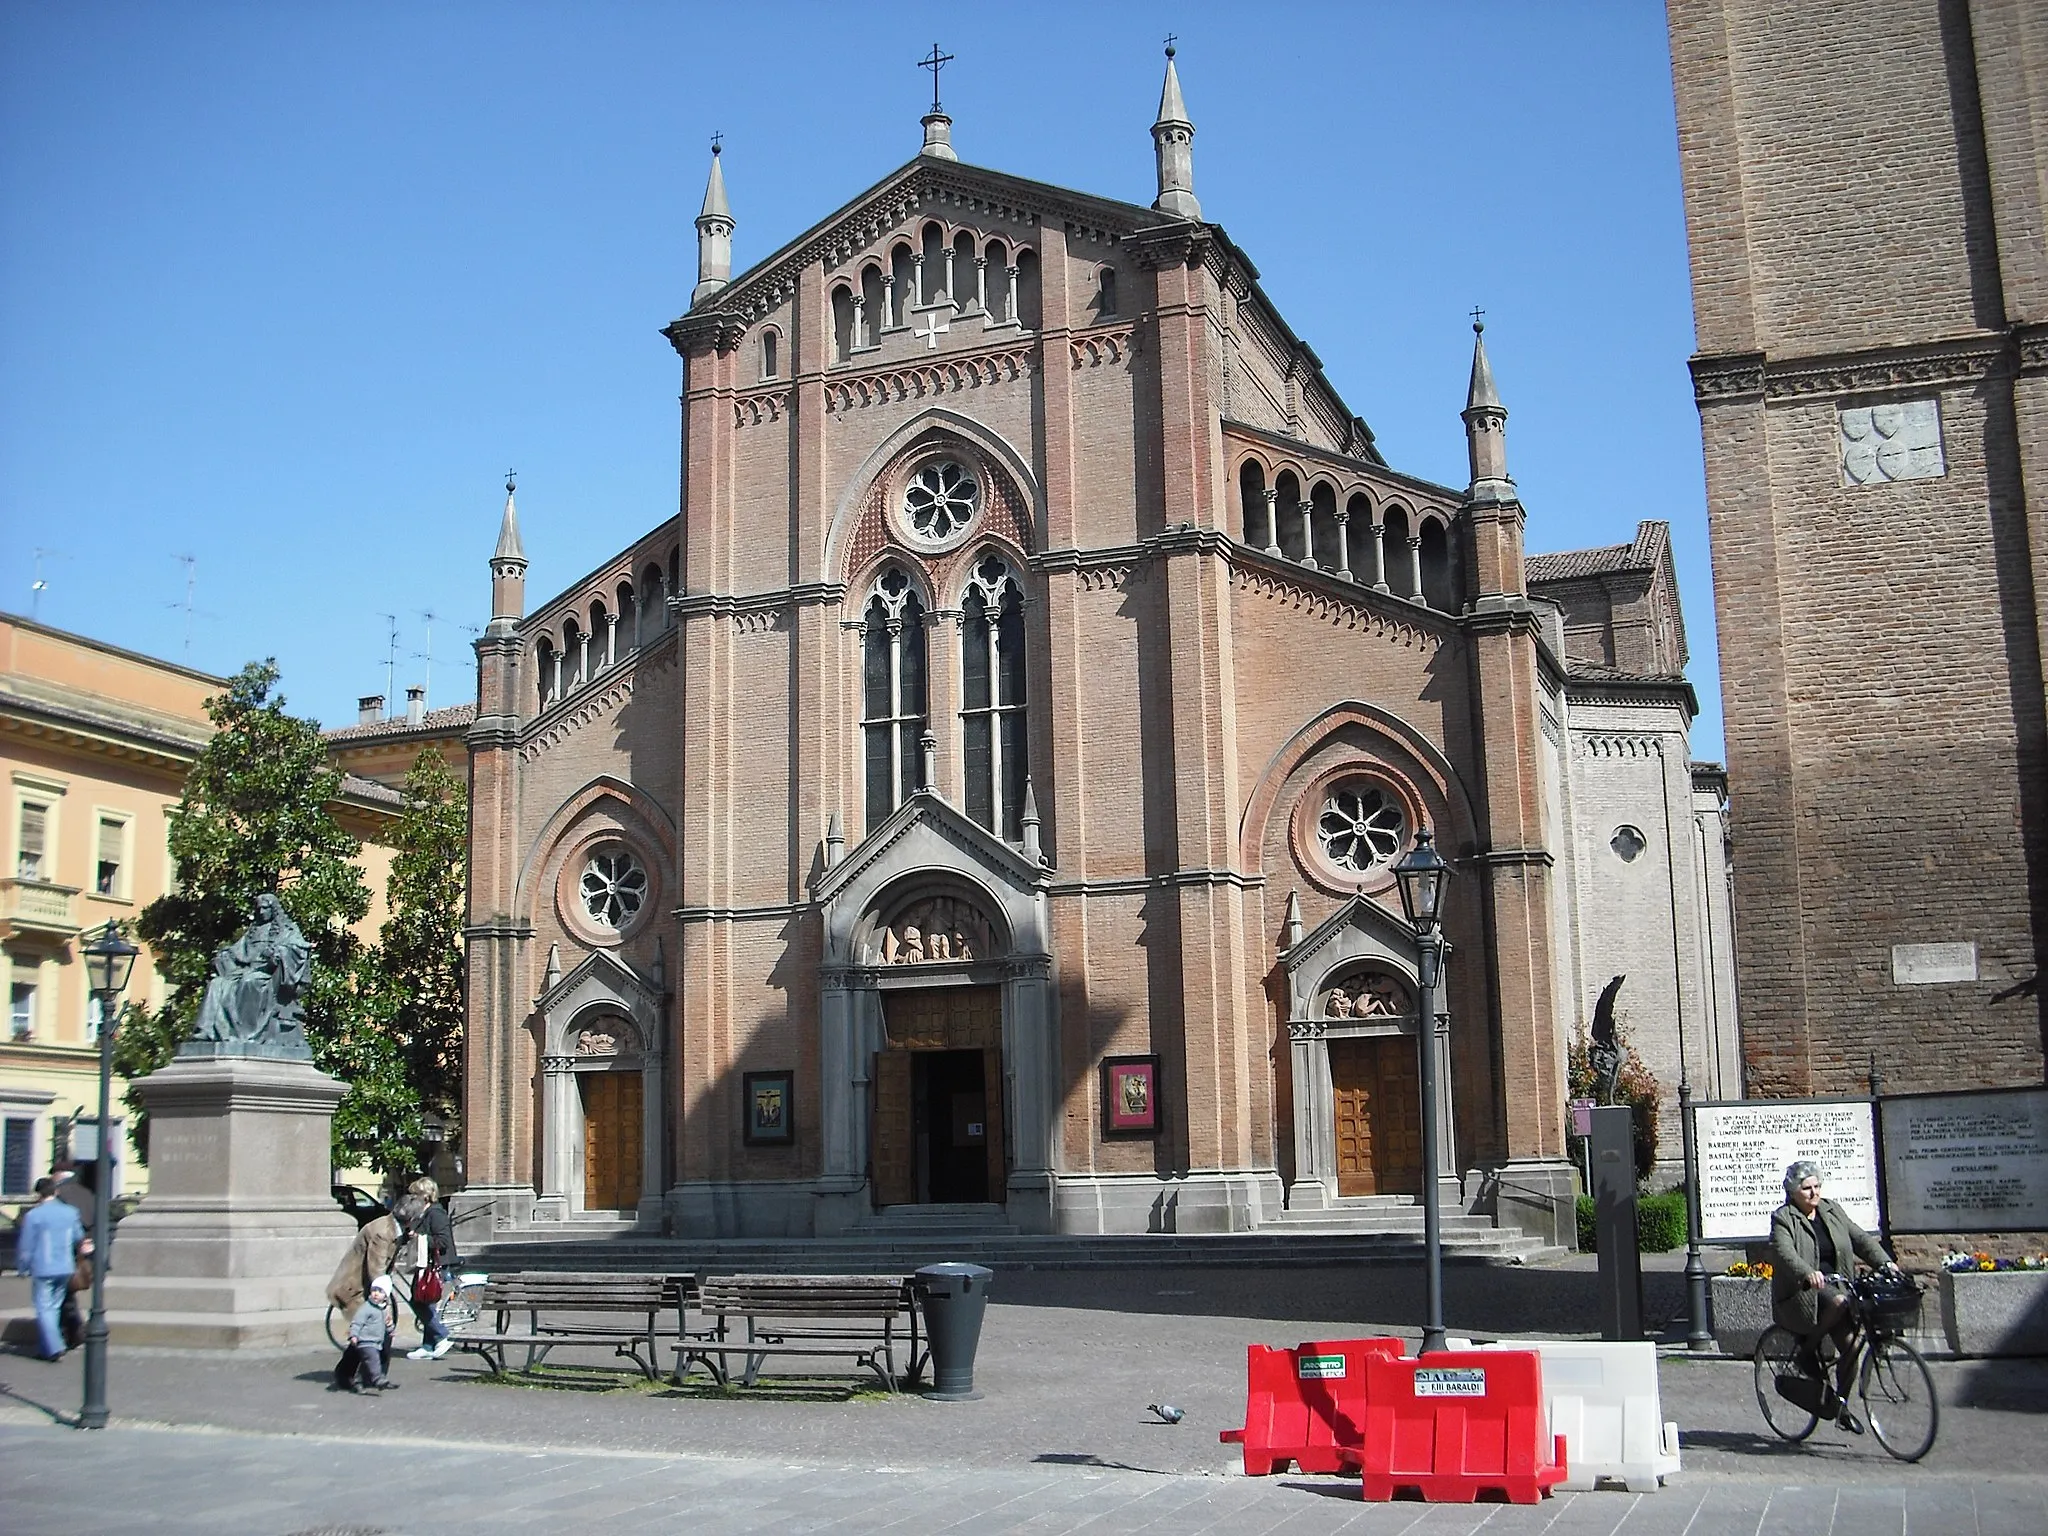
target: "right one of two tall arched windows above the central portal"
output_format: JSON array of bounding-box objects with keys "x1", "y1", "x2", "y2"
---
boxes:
[{"x1": 961, "y1": 555, "x2": 1030, "y2": 842}]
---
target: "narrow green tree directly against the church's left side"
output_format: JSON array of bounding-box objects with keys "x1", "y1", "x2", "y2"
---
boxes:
[{"x1": 379, "y1": 748, "x2": 469, "y2": 1138}]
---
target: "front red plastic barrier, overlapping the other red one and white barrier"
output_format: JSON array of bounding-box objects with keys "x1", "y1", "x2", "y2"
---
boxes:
[{"x1": 1360, "y1": 1350, "x2": 1565, "y2": 1503}]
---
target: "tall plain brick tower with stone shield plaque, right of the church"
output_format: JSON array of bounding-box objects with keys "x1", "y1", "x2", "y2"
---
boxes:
[{"x1": 1669, "y1": 0, "x2": 2048, "y2": 1096}]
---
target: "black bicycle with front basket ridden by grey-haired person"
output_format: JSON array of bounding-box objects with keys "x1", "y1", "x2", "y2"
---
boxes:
[{"x1": 1755, "y1": 1274, "x2": 1942, "y2": 1462}]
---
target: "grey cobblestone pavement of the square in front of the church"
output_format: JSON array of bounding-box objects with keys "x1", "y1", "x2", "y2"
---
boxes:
[{"x1": 0, "y1": 1270, "x2": 2048, "y2": 1536}]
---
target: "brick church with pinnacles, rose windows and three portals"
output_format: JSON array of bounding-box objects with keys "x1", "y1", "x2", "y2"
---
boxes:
[{"x1": 448, "y1": 49, "x2": 1739, "y2": 1245}]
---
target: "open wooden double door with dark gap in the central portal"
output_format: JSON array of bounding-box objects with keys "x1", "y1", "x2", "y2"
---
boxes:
[{"x1": 868, "y1": 987, "x2": 1010, "y2": 1206}]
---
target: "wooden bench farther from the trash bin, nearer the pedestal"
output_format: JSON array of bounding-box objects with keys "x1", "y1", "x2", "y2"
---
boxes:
[{"x1": 453, "y1": 1270, "x2": 696, "y2": 1380}]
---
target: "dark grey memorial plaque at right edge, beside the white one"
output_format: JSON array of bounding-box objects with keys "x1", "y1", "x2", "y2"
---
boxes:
[{"x1": 1882, "y1": 1087, "x2": 2048, "y2": 1233}]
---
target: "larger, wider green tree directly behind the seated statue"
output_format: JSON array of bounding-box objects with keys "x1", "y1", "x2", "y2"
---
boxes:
[{"x1": 115, "y1": 662, "x2": 420, "y2": 1167}]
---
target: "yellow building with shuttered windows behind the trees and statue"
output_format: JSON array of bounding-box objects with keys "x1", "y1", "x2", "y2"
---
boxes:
[{"x1": 0, "y1": 614, "x2": 399, "y2": 1206}]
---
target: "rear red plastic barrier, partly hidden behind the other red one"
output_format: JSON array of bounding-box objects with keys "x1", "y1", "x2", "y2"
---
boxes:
[{"x1": 1217, "y1": 1339, "x2": 1401, "y2": 1477}]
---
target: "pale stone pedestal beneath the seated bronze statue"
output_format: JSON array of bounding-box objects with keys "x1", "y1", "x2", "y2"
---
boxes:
[{"x1": 106, "y1": 1053, "x2": 356, "y2": 1350}]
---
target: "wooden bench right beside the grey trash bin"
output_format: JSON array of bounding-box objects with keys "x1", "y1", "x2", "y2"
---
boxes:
[{"x1": 676, "y1": 1274, "x2": 924, "y2": 1393}]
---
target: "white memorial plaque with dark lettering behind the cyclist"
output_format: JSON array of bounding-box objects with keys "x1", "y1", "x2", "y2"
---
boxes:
[{"x1": 1692, "y1": 1098, "x2": 1878, "y2": 1243}]
